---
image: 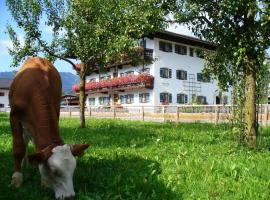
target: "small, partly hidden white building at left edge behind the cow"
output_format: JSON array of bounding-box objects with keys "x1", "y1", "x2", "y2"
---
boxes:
[{"x1": 0, "y1": 78, "x2": 12, "y2": 108}]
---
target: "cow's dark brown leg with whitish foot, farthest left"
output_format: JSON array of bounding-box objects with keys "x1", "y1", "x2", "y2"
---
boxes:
[{"x1": 10, "y1": 113, "x2": 26, "y2": 187}]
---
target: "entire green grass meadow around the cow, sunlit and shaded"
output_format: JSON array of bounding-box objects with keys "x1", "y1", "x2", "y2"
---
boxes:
[{"x1": 0, "y1": 114, "x2": 270, "y2": 200}]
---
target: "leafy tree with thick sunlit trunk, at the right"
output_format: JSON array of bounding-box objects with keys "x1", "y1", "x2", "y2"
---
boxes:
[{"x1": 173, "y1": 0, "x2": 270, "y2": 148}]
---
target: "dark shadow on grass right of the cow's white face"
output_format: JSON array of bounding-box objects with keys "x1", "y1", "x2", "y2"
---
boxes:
[{"x1": 74, "y1": 156, "x2": 179, "y2": 200}]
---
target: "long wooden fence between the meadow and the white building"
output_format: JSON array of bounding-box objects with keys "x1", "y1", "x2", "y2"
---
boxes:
[{"x1": 0, "y1": 104, "x2": 270, "y2": 124}]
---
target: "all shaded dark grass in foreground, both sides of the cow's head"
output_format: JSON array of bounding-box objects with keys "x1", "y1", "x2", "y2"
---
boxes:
[{"x1": 0, "y1": 152, "x2": 178, "y2": 200}]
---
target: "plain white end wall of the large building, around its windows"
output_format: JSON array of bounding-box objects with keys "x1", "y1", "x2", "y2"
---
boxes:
[{"x1": 154, "y1": 39, "x2": 229, "y2": 105}]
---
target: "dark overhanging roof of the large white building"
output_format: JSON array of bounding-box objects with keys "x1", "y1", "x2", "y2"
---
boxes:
[{"x1": 150, "y1": 31, "x2": 217, "y2": 50}]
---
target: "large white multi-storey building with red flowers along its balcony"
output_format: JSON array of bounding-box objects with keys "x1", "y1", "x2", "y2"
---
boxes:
[{"x1": 73, "y1": 31, "x2": 231, "y2": 106}]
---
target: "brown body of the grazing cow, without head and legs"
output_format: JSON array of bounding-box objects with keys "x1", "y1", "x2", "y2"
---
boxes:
[{"x1": 9, "y1": 57, "x2": 62, "y2": 149}]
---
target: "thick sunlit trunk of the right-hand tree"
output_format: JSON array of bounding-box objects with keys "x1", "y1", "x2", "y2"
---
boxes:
[{"x1": 244, "y1": 63, "x2": 257, "y2": 148}]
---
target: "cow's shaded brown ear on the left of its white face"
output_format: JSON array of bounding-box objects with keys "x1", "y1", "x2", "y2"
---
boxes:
[{"x1": 28, "y1": 145, "x2": 55, "y2": 165}]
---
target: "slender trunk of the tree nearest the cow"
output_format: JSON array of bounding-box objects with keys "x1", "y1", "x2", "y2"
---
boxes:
[{"x1": 79, "y1": 65, "x2": 85, "y2": 128}]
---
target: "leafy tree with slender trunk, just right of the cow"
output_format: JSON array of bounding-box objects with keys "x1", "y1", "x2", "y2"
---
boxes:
[{"x1": 7, "y1": 0, "x2": 167, "y2": 127}]
